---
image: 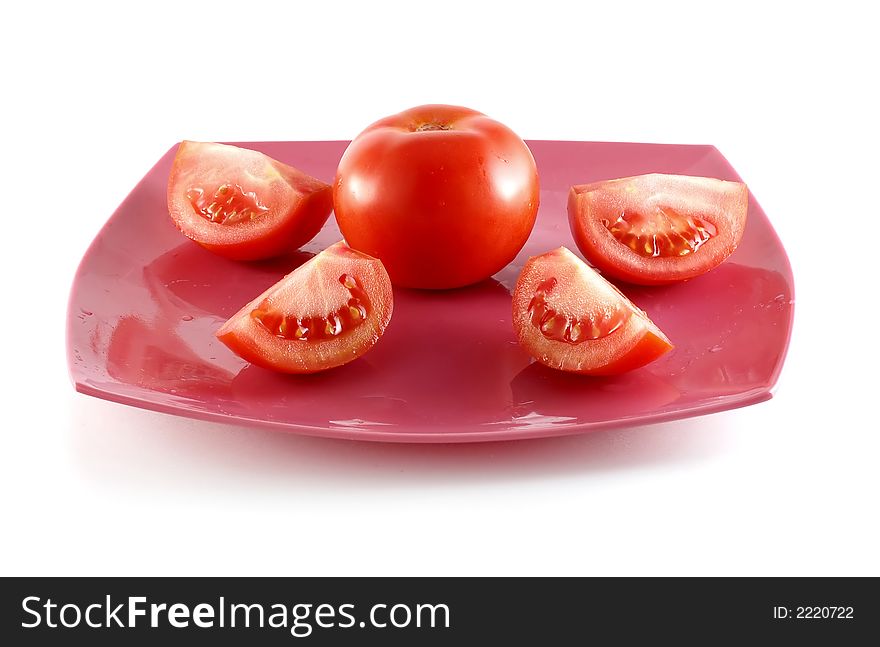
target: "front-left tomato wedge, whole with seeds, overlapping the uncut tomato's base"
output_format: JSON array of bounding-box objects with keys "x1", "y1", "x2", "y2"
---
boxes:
[{"x1": 216, "y1": 242, "x2": 393, "y2": 373}]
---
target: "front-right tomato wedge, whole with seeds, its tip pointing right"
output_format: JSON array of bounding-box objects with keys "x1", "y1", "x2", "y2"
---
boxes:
[{"x1": 513, "y1": 247, "x2": 672, "y2": 375}]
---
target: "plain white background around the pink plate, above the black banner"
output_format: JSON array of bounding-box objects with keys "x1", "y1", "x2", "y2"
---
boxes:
[{"x1": 0, "y1": 0, "x2": 880, "y2": 575}]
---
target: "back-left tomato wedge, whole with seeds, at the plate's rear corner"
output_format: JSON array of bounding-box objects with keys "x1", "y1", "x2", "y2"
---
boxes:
[{"x1": 168, "y1": 141, "x2": 333, "y2": 260}]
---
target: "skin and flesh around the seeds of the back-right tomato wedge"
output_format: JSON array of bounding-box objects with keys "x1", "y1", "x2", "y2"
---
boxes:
[{"x1": 568, "y1": 173, "x2": 749, "y2": 285}]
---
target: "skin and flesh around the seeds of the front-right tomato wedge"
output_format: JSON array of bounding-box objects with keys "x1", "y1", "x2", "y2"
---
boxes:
[{"x1": 512, "y1": 247, "x2": 673, "y2": 376}]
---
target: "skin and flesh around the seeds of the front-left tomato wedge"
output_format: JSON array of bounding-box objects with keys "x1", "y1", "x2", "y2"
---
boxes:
[{"x1": 215, "y1": 242, "x2": 394, "y2": 374}]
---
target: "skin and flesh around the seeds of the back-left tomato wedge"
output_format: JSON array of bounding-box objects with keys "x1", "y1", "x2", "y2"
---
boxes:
[{"x1": 168, "y1": 141, "x2": 333, "y2": 261}]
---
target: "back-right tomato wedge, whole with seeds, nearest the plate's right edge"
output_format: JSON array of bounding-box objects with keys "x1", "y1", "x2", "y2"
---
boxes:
[{"x1": 568, "y1": 173, "x2": 749, "y2": 285}]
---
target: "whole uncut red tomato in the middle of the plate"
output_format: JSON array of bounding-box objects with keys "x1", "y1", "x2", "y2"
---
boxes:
[{"x1": 333, "y1": 105, "x2": 538, "y2": 289}]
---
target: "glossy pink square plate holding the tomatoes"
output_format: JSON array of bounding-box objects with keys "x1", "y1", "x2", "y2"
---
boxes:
[{"x1": 67, "y1": 141, "x2": 793, "y2": 442}]
